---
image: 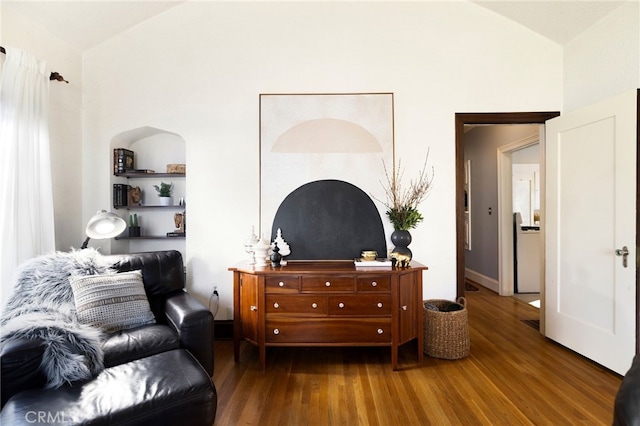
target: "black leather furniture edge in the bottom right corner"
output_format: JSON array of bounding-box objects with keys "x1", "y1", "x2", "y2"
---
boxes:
[{"x1": 613, "y1": 354, "x2": 640, "y2": 426}]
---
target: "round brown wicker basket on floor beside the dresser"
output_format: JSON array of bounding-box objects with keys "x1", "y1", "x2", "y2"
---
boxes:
[{"x1": 423, "y1": 297, "x2": 471, "y2": 359}]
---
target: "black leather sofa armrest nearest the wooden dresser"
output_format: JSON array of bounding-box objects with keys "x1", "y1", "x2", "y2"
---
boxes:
[{"x1": 165, "y1": 291, "x2": 214, "y2": 376}]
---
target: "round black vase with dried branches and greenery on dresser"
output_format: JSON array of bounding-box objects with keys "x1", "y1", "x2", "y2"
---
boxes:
[{"x1": 374, "y1": 151, "x2": 434, "y2": 263}]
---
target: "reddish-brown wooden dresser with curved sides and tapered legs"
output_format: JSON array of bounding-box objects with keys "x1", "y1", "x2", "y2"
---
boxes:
[{"x1": 229, "y1": 261, "x2": 427, "y2": 370}]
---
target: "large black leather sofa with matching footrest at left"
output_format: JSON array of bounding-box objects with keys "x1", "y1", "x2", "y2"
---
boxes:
[{"x1": 0, "y1": 250, "x2": 217, "y2": 425}]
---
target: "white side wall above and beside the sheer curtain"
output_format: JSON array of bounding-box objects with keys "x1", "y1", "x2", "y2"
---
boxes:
[{"x1": 0, "y1": 4, "x2": 84, "y2": 251}]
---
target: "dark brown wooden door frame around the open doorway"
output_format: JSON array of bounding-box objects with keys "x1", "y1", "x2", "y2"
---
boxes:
[{"x1": 455, "y1": 111, "x2": 560, "y2": 297}]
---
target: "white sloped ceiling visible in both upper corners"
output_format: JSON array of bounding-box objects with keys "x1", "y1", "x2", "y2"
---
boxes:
[{"x1": 2, "y1": 0, "x2": 636, "y2": 51}]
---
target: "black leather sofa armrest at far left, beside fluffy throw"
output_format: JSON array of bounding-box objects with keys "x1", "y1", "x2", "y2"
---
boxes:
[{"x1": 0, "y1": 338, "x2": 46, "y2": 407}]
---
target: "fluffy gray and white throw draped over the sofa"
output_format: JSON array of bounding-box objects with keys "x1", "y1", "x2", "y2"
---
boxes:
[{"x1": 0, "y1": 249, "x2": 114, "y2": 388}]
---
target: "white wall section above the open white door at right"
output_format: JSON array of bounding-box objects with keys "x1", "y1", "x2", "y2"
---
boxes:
[{"x1": 563, "y1": 0, "x2": 640, "y2": 112}]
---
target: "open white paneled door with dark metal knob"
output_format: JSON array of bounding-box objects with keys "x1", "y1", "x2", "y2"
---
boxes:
[{"x1": 545, "y1": 90, "x2": 637, "y2": 374}]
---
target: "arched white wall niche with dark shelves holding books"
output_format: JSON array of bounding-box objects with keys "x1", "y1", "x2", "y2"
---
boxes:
[{"x1": 110, "y1": 127, "x2": 187, "y2": 256}]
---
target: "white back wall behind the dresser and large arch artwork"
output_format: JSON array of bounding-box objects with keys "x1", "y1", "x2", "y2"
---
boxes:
[{"x1": 83, "y1": 2, "x2": 562, "y2": 319}]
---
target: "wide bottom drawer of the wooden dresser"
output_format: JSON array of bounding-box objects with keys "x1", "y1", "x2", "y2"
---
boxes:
[{"x1": 265, "y1": 318, "x2": 391, "y2": 346}]
